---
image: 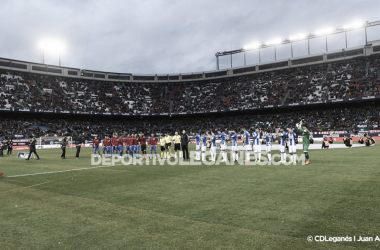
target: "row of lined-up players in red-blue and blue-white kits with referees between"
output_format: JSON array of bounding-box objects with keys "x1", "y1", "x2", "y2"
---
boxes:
[{"x1": 61, "y1": 122, "x2": 310, "y2": 164}]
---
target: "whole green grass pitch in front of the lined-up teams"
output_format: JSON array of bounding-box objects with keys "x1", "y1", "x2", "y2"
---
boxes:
[{"x1": 0, "y1": 145, "x2": 380, "y2": 249}]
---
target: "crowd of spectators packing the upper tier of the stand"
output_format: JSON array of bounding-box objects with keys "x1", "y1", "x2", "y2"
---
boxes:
[{"x1": 0, "y1": 55, "x2": 380, "y2": 113}]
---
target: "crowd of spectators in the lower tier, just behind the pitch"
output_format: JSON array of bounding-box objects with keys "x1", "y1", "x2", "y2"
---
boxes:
[{"x1": 0, "y1": 104, "x2": 380, "y2": 140}]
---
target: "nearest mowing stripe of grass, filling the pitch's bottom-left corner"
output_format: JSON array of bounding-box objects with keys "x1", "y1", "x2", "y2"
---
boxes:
[{"x1": 0, "y1": 183, "x2": 355, "y2": 249}]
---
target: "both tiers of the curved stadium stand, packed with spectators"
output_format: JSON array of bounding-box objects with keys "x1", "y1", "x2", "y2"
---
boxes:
[{"x1": 0, "y1": 54, "x2": 380, "y2": 141}]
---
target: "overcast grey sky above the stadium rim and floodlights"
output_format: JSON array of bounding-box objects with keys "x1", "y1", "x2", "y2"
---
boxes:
[{"x1": 0, "y1": 0, "x2": 380, "y2": 74}]
